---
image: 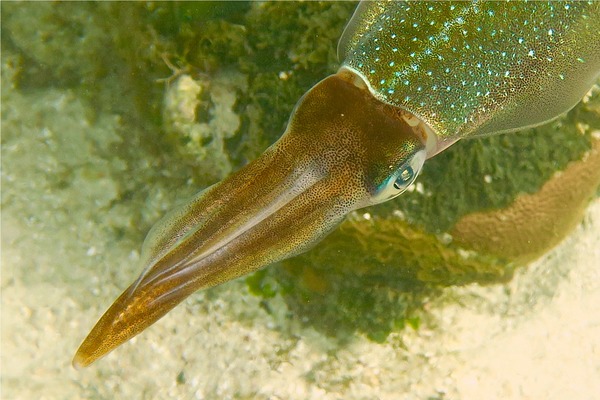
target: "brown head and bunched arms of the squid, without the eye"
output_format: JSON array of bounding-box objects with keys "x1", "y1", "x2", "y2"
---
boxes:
[{"x1": 73, "y1": 72, "x2": 424, "y2": 367}]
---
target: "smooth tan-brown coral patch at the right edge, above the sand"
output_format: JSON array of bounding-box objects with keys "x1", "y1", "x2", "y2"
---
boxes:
[{"x1": 452, "y1": 138, "x2": 600, "y2": 262}]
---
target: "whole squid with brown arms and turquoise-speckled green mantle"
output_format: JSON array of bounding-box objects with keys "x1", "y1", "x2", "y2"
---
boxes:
[{"x1": 73, "y1": 1, "x2": 600, "y2": 367}]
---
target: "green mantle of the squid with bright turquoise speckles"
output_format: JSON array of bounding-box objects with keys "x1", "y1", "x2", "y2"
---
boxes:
[{"x1": 338, "y1": 1, "x2": 600, "y2": 151}]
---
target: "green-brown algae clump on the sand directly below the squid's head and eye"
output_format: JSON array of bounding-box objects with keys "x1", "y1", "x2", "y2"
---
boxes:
[{"x1": 247, "y1": 215, "x2": 515, "y2": 341}]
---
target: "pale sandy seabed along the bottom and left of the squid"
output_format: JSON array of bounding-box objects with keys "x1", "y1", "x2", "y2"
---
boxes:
[{"x1": 1, "y1": 86, "x2": 600, "y2": 400}]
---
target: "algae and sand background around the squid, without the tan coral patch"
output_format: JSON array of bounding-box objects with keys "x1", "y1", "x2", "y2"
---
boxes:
[{"x1": 1, "y1": 2, "x2": 600, "y2": 400}]
